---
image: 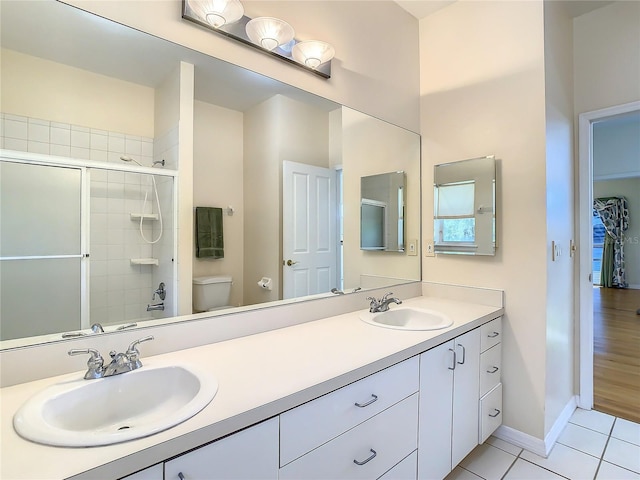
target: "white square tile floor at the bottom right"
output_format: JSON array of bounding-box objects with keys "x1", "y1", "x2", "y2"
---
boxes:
[{"x1": 446, "y1": 409, "x2": 640, "y2": 480}]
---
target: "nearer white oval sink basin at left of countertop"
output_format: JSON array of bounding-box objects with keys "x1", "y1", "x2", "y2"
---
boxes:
[{"x1": 13, "y1": 365, "x2": 218, "y2": 447}]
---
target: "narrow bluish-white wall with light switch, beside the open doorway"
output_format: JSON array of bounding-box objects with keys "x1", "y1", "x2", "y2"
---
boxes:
[{"x1": 544, "y1": 1, "x2": 577, "y2": 441}]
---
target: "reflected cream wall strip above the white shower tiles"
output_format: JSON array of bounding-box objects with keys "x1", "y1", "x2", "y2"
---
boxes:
[{"x1": 0, "y1": 48, "x2": 154, "y2": 137}]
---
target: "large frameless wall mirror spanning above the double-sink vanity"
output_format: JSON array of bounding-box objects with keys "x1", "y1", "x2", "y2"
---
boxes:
[{"x1": 0, "y1": 0, "x2": 420, "y2": 348}]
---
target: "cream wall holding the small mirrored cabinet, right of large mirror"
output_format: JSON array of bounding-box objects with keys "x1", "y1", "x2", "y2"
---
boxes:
[{"x1": 420, "y1": 1, "x2": 548, "y2": 439}]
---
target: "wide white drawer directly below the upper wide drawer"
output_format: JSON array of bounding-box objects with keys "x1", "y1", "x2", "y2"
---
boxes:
[{"x1": 279, "y1": 393, "x2": 418, "y2": 480}]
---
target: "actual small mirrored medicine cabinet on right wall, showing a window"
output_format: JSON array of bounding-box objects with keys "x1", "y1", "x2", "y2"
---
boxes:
[{"x1": 433, "y1": 156, "x2": 496, "y2": 255}]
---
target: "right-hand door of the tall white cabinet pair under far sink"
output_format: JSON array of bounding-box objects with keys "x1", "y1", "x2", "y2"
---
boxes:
[{"x1": 451, "y1": 328, "x2": 480, "y2": 468}]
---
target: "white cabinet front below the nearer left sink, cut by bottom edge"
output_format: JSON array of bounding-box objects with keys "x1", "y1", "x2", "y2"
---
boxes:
[{"x1": 164, "y1": 418, "x2": 278, "y2": 480}]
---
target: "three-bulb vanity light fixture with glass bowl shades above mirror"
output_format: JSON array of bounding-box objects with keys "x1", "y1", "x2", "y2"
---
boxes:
[{"x1": 182, "y1": 0, "x2": 335, "y2": 78}]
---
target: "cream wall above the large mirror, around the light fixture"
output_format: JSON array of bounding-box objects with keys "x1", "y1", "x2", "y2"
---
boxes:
[{"x1": 60, "y1": 0, "x2": 420, "y2": 131}]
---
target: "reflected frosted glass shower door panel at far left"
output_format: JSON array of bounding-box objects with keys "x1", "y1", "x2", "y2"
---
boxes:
[{"x1": 0, "y1": 161, "x2": 83, "y2": 340}]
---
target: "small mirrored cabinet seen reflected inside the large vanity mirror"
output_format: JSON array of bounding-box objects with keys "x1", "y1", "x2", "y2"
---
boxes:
[{"x1": 360, "y1": 171, "x2": 407, "y2": 252}]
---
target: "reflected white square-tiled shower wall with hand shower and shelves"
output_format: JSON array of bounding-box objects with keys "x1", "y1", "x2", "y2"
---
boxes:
[{"x1": 0, "y1": 110, "x2": 172, "y2": 325}]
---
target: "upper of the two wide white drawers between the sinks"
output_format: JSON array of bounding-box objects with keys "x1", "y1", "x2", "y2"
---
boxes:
[{"x1": 280, "y1": 357, "x2": 419, "y2": 466}]
